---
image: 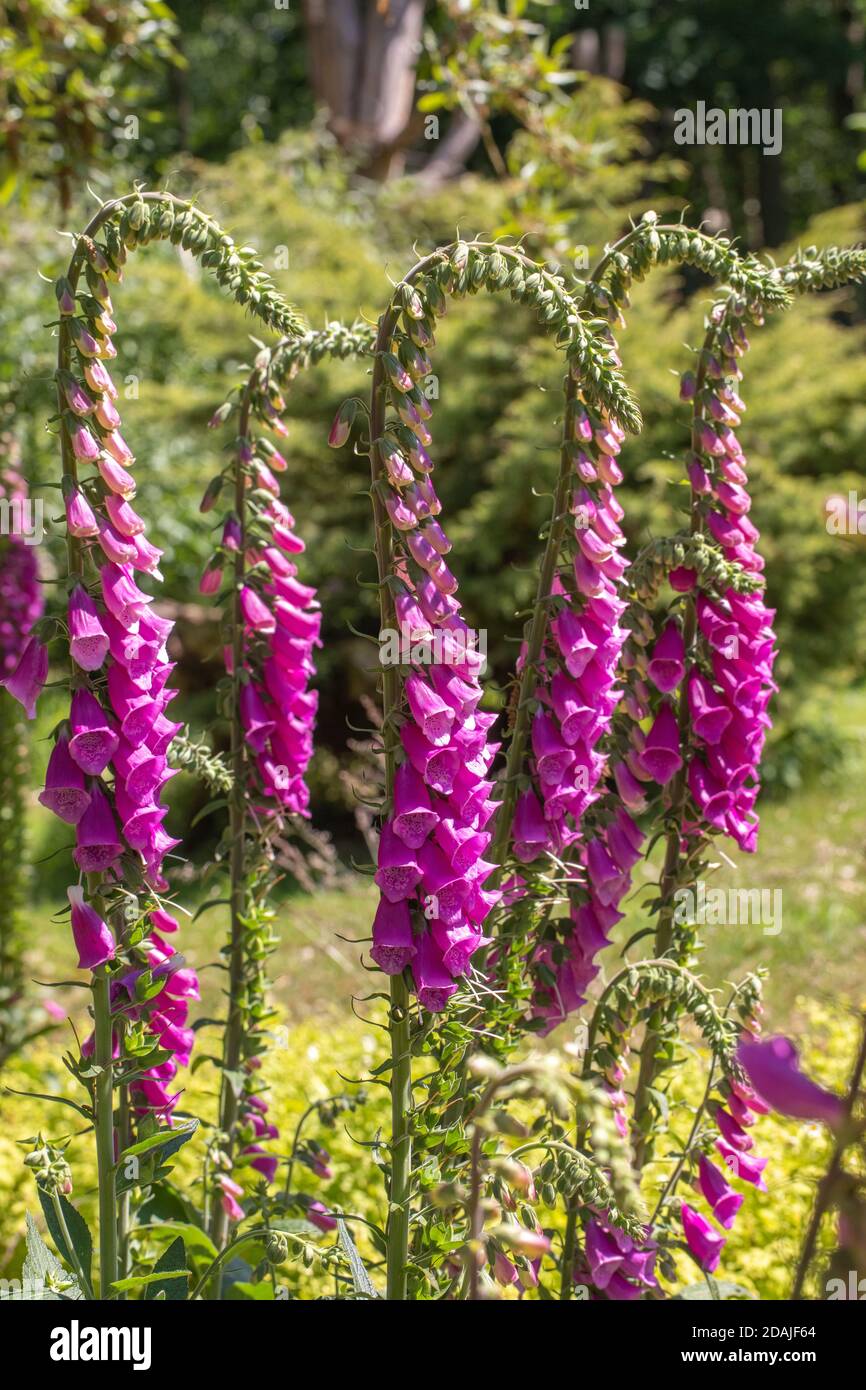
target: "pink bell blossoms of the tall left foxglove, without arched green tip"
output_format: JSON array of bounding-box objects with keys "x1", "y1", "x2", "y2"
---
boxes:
[{"x1": 39, "y1": 243, "x2": 199, "y2": 1119}]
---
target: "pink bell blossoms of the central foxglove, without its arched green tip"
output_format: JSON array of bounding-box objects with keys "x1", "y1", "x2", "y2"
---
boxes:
[{"x1": 371, "y1": 295, "x2": 499, "y2": 1013}]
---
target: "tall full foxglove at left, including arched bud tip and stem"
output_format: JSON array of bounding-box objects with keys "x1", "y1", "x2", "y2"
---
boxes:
[{"x1": 14, "y1": 190, "x2": 308, "y2": 1297}]
